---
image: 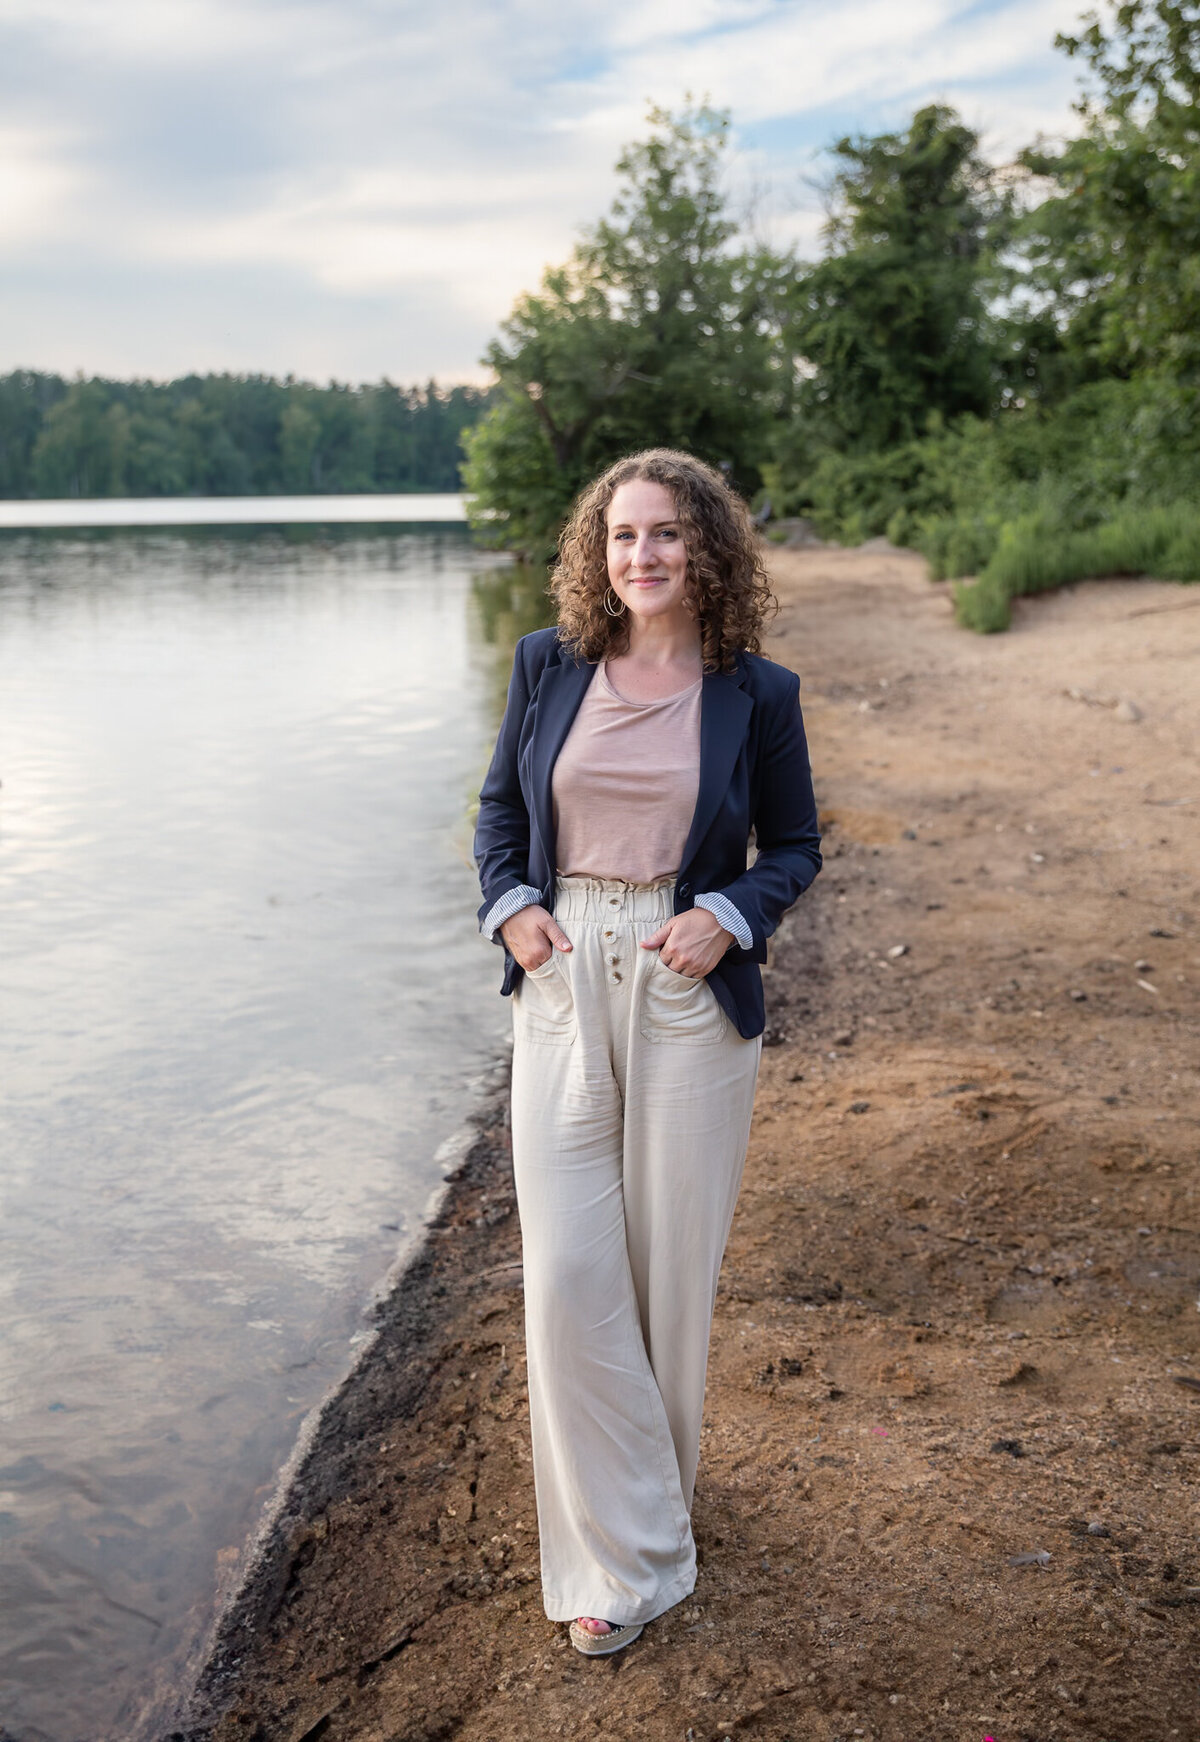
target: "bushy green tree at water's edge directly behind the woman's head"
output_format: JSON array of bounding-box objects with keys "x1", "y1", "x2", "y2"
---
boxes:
[{"x1": 463, "y1": 106, "x2": 787, "y2": 554}]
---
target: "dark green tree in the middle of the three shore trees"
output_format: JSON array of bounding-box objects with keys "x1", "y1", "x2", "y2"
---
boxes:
[{"x1": 787, "y1": 105, "x2": 1007, "y2": 453}]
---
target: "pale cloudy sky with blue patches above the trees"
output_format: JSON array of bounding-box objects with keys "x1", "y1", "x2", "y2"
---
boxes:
[{"x1": 0, "y1": 0, "x2": 1085, "y2": 383}]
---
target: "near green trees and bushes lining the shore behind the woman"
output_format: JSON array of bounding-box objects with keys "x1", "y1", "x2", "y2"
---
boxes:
[{"x1": 465, "y1": 0, "x2": 1200, "y2": 629}]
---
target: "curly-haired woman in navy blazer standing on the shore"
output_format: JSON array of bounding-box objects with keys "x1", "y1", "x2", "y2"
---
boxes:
[{"x1": 475, "y1": 449, "x2": 820, "y2": 1655}]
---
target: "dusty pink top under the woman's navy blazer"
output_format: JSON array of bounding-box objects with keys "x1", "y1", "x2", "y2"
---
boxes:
[{"x1": 550, "y1": 660, "x2": 704, "y2": 883}]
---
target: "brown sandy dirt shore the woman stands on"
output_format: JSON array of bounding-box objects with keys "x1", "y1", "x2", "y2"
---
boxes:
[{"x1": 176, "y1": 549, "x2": 1200, "y2": 1742}]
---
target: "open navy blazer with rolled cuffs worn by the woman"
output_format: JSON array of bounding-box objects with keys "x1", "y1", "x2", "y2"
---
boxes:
[{"x1": 475, "y1": 629, "x2": 820, "y2": 1040}]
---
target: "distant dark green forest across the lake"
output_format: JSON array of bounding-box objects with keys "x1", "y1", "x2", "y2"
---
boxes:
[{"x1": 0, "y1": 369, "x2": 493, "y2": 498}]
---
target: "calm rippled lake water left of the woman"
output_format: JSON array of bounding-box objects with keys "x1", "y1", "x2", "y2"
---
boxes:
[{"x1": 0, "y1": 531, "x2": 519, "y2": 1742}]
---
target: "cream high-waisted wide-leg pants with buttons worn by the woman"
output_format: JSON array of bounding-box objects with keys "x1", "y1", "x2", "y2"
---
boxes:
[{"x1": 512, "y1": 876, "x2": 763, "y2": 1622}]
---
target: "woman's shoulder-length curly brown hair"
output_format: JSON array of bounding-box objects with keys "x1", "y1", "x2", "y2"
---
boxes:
[{"x1": 550, "y1": 448, "x2": 779, "y2": 671}]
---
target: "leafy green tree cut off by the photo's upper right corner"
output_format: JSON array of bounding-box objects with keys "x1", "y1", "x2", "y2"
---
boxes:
[{"x1": 1022, "y1": 0, "x2": 1200, "y2": 381}]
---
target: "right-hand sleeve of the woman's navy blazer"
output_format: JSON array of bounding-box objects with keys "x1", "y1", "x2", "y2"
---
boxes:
[{"x1": 707, "y1": 672, "x2": 820, "y2": 962}]
